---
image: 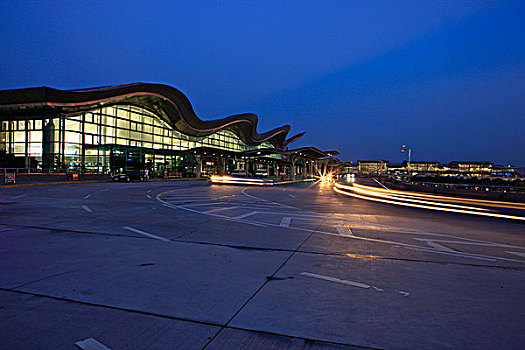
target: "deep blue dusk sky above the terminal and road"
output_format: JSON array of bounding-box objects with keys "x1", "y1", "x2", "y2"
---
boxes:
[{"x1": 0, "y1": 0, "x2": 525, "y2": 166}]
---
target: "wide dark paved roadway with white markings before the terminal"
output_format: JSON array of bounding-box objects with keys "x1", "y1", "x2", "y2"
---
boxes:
[{"x1": 0, "y1": 182, "x2": 525, "y2": 350}]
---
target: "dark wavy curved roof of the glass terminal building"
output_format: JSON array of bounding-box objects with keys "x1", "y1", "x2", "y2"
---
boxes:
[{"x1": 0, "y1": 83, "x2": 304, "y2": 148}]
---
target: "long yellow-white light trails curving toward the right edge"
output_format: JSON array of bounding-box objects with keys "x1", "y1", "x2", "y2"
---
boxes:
[{"x1": 334, "y1": 183, "x2": 525, "y2": 221}]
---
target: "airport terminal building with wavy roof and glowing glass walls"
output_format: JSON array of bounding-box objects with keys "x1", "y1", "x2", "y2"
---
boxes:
[{"x1": 0, "y1": 83, "x2": 334, "y2": 178}]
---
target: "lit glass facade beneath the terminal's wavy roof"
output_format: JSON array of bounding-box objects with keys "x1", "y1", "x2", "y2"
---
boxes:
[{"x1": 0, "y1": 106, "x2": 281, "y2": 173}]
